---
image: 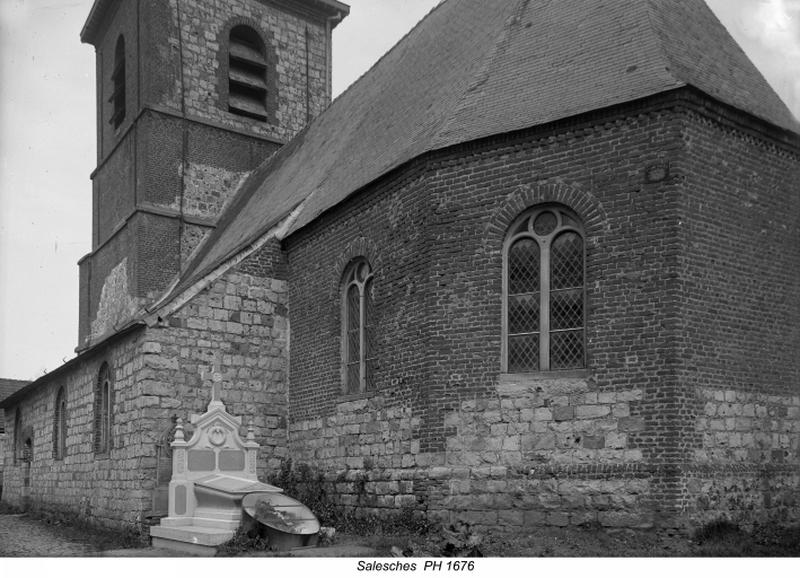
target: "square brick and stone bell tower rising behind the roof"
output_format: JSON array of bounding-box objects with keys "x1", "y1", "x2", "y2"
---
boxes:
[{"x1": 78, "y1": 0, "x2": 349, "y2": 350}]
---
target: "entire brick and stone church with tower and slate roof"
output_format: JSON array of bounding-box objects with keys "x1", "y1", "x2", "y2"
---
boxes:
[{"x1": 0, "y1": 0, "x2": 800, "y2": 530}]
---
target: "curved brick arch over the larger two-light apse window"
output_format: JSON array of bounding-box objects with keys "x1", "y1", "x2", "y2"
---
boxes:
[{"x1": 484, "y1": 183, "x2": 608, "y2": 250}]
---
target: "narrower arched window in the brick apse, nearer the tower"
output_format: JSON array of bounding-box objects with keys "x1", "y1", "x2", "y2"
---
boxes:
[{"x1": 342, "y1": 258, "x2": 375, "y2": 393}]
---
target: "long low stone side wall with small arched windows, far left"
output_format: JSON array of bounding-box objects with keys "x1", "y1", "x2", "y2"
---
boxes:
[{"x1": 3, "y1": 331, "x2": 154, "y2": 527}]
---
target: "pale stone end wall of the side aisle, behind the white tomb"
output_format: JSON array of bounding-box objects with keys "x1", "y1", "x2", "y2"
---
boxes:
[{"x1": 148, "y1": 272, "x2": 288, "y2": 478}]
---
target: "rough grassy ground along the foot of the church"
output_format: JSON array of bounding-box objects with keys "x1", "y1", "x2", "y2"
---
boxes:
[{"x1": 0, "y1": 506, "x2": 800, "y2": 557}]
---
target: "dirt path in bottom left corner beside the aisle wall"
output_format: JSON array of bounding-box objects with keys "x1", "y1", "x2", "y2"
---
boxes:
[{"x1": 0, "y1": 514, "x2": 97, "y2": 557}]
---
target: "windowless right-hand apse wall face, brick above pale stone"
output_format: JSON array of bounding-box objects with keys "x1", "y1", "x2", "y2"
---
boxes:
[{"x1": 678, "y1": 102, "x2": 800, "y2": 523}]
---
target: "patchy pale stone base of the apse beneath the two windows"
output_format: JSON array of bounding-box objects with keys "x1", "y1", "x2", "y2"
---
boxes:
[{"x1": 289, "y1": 376, "x2": 655, "y2": 529}]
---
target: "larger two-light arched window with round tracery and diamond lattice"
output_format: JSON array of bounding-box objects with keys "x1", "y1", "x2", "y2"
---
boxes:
[{"x1": 503, "y1": 205, "x2": 586, "y2": 373}]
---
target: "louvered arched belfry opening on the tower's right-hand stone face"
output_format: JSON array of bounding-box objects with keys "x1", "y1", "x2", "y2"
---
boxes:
[{"x1": 228, "y1": 26, "x2": 267, "y2": 120}]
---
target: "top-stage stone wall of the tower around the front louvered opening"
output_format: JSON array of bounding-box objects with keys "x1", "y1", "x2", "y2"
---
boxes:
[{"x1": 142, "y1": 0, "x2": 330, "y2": 142}]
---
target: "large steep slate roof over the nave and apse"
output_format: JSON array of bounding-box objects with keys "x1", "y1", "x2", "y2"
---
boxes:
[{"x1": 167, "y1": 0, "x2": 800, "y2": 304}]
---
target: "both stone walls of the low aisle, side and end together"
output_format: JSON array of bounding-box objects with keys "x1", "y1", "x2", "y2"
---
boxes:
[{"x1": 3, "y1": 244, "x2": 288, "y2": 527}]
